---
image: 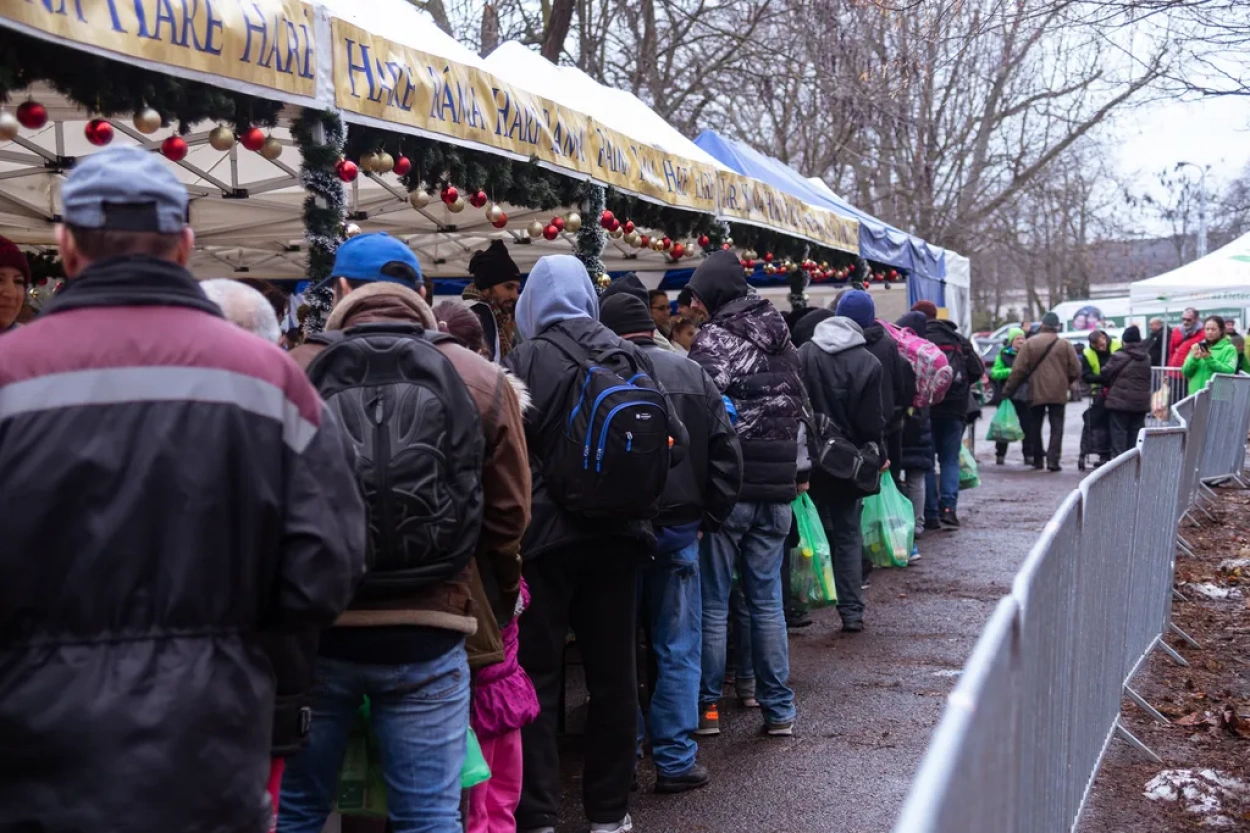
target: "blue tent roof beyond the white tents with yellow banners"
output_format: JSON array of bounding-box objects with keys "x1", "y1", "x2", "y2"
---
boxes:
[{"x1": 695, "y1": 130, "x2": 946, "y2": 280}]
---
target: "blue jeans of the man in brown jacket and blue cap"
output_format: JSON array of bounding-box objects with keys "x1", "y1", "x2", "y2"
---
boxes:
[{"x1": 278, "y1": 643, "x2": 469, "y2": 833}]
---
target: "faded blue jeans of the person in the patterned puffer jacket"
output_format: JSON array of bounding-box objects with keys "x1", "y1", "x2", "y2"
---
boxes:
[{"x1": 699, "y1": 503, "x2": 795, "y2": 724}]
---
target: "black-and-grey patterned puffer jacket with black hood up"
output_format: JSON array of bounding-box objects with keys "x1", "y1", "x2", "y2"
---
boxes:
[{"x1": 689, "y1": 251, "x2": 808, "y2": 503}]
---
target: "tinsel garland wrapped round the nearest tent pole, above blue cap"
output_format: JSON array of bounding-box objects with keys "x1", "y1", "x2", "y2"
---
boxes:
[{"x1": 291, "y1": 108, "x2": 346, "y2": 333}]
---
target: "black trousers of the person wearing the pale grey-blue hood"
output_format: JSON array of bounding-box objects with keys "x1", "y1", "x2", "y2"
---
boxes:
[{"x1": 516, "y1": 539, "x2": 643, "y2": 830}]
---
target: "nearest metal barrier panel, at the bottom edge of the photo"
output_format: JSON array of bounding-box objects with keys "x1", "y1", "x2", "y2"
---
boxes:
[{"x1": 894, "y1": 597, "x2": 1021, "y2": 833}]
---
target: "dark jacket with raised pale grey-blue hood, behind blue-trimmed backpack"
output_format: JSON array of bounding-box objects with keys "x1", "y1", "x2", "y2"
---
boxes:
[{"x1": 504, "y1": 255, "x2": 688, "y2": 559}]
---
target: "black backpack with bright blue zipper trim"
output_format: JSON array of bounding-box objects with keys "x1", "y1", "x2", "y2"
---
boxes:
[{"x1": 538, "y1": 330, "x2": 671, "y2": 520}]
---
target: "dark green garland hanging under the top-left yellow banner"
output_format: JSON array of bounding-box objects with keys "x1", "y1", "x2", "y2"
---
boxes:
[{"x1": 0, "y1": 30, "x2": 283, "y2": 134}]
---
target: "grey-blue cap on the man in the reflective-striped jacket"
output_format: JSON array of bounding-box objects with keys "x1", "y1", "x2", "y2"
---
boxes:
[{"x1": 61, "y1": 148, "x2": 188, "y2": 234}]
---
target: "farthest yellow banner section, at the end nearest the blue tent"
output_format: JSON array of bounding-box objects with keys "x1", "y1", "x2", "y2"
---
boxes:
[{"x1": 719, "y1": 171, "x2": 859, "y2": 253}]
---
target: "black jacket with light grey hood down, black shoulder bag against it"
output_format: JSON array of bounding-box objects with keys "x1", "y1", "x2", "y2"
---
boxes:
[{"x1": 799, "y1": 316, "x2": 886, "y2": 500}]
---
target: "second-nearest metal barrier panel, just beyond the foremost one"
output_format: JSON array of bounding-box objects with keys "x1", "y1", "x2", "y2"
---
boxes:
[{"x1": 1011, "y1": 492, "x2": 1084, "y2": 833}]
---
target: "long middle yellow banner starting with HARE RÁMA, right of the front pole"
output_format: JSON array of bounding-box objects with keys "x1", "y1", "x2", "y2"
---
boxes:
[{"x1": 331, "y1": 19, "x2": 716, "y2": 213}]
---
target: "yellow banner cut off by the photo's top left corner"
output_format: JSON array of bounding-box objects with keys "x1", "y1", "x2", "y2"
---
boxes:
[{"x1": 0, "y1": 0, "x2": 316, "y2": 98}]
